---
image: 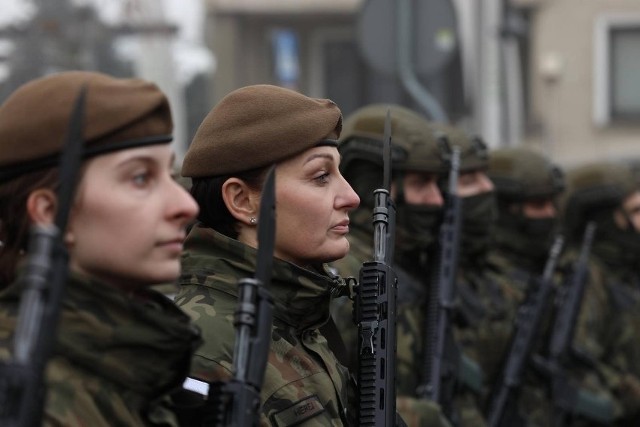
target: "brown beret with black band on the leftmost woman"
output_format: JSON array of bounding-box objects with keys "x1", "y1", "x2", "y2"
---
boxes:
[{"x1": 0, "y1": 71, "x2": 173, "y2": 181}]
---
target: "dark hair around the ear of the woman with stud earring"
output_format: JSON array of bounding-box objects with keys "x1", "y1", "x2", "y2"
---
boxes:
[{"x1": 191, "y1": 167, "x2": 269, "y2": 239}]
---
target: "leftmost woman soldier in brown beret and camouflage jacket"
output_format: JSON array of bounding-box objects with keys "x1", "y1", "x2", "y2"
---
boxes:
[{"x1": 0, "y1": 71, "x2": 199, "y2": 426}]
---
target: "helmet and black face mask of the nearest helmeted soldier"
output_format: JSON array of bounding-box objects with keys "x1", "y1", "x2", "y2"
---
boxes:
[{"x1": 338, "y1": 104, "x2": 448, "y2": 260}]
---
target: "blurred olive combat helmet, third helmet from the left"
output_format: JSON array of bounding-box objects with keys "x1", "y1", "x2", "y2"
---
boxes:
[{"x1": 487, "y1": 147, "x2": 565, "y2": 202}]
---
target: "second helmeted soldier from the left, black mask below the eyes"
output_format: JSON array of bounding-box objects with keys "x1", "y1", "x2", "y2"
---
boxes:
[{"x1": 428, "y1": 125, "x2": 514, "y2": 426}]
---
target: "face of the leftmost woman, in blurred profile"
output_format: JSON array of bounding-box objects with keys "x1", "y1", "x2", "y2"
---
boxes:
[{"x1": 65, "y1": 145, "x2": 198, "y2": 288}]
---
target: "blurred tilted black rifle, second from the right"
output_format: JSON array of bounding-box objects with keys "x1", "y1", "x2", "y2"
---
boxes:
[{"x1": 487, "y1": 236, "x2": 564, "y2": 427}]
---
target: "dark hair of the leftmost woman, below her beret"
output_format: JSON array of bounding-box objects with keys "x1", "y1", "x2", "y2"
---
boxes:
[{"x1": 0, "y1": 168, "x2": 59, "y2": 288}]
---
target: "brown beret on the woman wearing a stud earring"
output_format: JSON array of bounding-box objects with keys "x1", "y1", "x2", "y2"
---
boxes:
[{"x1": 182, "y1": 85, "x2": 342, "y2": 178}]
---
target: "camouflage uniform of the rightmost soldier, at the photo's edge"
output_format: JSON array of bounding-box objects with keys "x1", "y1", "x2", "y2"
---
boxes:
[{"x1": 563, "y1": 247, "x2": 640, "y2": 425}]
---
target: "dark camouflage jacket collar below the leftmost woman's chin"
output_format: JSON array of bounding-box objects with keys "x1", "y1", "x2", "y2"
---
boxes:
[{"x1": 57, "y1": 277, "x2": 200, "y2": 397}]
